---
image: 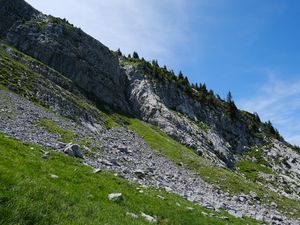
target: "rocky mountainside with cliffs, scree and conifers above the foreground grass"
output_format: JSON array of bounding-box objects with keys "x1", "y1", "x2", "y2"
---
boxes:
[{"x1": 0, "y1": 0, "x2": 300, "y2": 224}]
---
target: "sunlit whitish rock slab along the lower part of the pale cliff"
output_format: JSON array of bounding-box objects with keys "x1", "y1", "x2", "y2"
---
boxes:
[{"x1": 126, "y1": 67, "x2": 233, "y2": 165}]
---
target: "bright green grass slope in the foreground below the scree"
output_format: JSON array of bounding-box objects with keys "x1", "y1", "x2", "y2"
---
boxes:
[{"x1": 0, "y1": 134, "x2": 256, "y2": 225}]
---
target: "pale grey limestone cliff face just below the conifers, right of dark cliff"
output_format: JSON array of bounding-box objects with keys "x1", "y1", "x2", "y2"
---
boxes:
[{"x1": 124, "y1": 66, "x2": 257, "y2": 166}]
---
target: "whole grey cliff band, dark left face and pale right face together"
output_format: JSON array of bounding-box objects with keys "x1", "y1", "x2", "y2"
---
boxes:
[{"x1": 0, "y1": 0, "x2": 282, "y2": 167}]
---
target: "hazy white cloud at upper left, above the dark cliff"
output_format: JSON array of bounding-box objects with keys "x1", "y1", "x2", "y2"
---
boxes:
[{"x1": 27, "y1": 0, "x2": 186, "y2": 63}]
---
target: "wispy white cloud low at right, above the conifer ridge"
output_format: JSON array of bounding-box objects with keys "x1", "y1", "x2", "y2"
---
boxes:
[{"x1": 238, "y1": 71, "x2": 300, "y2": 145}]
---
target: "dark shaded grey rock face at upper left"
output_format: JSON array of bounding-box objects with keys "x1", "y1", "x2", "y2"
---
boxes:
[{"x1": 0, "y1": 0, "x2": 129, "y2": 113}]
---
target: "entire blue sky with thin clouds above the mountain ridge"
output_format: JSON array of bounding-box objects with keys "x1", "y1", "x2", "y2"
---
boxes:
[{"x1": 27, "y1": 0, "x2": 300, "y2": 145}]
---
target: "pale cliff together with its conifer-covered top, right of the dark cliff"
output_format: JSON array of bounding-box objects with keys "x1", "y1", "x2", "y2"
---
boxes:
[{"x1": 120, "y1": 56, "x2": 282, "y2": 166}]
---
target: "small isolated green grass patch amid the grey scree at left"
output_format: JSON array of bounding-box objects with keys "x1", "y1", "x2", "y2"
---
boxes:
[{"x1": 36, "y1": 119, "x2": 76, "y2": 143}]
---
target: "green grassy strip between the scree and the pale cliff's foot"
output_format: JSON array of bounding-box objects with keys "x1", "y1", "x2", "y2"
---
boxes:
[{"x1": 128, "y1": 119, "x2": 300, "y2": 219}]
